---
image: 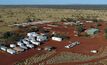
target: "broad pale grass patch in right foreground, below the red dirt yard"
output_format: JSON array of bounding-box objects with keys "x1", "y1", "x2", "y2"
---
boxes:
[{"x1": 47, "y1": 52, "x2": 96, "y2": 64}]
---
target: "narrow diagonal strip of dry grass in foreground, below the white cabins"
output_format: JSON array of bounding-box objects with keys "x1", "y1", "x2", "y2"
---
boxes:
[{"x1": 15, "y1": 51, "x2": 55, "y2": 65}]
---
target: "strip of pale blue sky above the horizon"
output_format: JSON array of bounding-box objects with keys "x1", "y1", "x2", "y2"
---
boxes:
[{"x1": 0, "y1": 0, "x2": 107, "y2": 5}]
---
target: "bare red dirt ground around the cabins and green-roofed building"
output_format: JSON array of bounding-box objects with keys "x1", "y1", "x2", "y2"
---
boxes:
[{"x1": 0, "y1": 23, "x2": 107, "y2": 65}]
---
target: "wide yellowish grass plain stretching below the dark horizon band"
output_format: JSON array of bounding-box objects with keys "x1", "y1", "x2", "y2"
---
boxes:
[{"x1": 0, "y1": 8, "x2": 107, "y2": 32}]
